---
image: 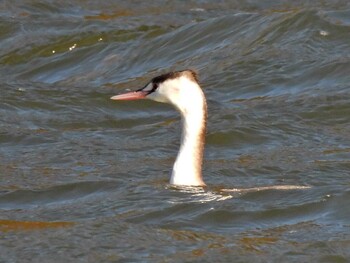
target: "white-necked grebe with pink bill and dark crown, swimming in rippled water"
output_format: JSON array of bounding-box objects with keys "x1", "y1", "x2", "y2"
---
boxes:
[{"x1": 111, "y1": 69, "x2": 207, "y2": 187}]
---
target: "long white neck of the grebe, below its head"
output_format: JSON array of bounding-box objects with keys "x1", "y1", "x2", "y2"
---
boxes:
[{"x1": 170, "y1": 90, "x2": 207, "y2": 186}]
